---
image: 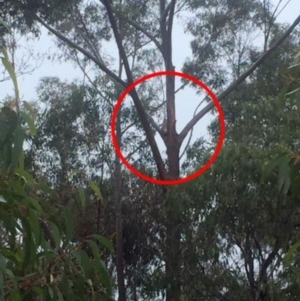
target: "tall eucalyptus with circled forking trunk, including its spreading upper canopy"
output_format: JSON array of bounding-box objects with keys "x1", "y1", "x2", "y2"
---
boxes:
[{"x1": 1, "y1": 0, "x2": 300, "y2": 301}]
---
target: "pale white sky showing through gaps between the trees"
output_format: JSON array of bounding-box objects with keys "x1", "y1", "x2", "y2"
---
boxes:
[{"x1": 0, "y1": 0, "x2": 300, "y2": 169}]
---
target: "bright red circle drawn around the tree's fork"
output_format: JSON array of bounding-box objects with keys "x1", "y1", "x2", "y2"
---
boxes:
[{"x1": 111, "y1": 71, "x2": 225, "y2": 185}]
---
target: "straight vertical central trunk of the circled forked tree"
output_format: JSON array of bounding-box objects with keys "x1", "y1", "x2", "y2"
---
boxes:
[{"x1": 160, "y1": 0, "x2": 181, "y2": 301}]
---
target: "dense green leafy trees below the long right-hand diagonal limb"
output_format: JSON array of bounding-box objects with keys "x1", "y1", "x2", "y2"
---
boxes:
[{"x1": 177, "y1": 31, "x2": 300, "y2": 300}]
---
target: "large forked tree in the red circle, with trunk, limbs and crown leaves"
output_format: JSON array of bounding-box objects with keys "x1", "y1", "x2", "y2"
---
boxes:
[{"x1": 1, "y1": 0, "x2": 300, "y2": 301}]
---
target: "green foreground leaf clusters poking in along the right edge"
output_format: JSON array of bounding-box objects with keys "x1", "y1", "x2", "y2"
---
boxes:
[{"x1": 264, "y1": 46, "x2": 299, "y2": 300}]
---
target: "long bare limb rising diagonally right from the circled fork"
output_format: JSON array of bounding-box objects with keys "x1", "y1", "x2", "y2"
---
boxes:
[{"x1": 178, "y1": 15, "x2": 300, "y2": 145}]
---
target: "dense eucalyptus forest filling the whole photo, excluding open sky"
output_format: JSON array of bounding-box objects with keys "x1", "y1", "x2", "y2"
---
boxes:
[{"x1": 0, "y1": 0, "x2": 300, "y2": 301}]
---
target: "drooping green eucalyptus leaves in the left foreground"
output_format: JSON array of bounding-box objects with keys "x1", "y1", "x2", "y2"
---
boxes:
[{"x1": 0, "y1": 43, "x2": 113, "y2": 300}]
